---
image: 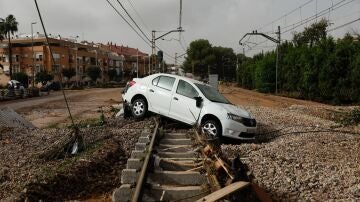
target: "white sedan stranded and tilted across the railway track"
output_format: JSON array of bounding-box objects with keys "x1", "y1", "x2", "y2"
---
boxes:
[{"x1": 122, "y1": 74, "x2": 256, "y2": 139}]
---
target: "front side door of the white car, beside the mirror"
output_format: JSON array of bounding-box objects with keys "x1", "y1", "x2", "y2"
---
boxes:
[{"x1": 169, "y1": 79, "x2": 200, "y2": 124}]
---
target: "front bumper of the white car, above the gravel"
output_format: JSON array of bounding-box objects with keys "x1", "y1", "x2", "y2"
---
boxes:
[{"x1": 222, "y1": 119, "x2": 257, "y2": 140}]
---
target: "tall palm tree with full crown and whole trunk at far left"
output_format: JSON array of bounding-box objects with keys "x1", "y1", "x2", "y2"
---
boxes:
[{"x1": 2, "y1": 14, "x2": 19, "y2": 77}]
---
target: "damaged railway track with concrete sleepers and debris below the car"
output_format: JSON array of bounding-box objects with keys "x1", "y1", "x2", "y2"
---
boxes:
[{"x1": 112, "y1": 118, "x2": 271, "y2": 202}]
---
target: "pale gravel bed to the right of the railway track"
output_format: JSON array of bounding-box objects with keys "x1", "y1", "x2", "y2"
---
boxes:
[{"x1": 222, "y1": 107, "x2": 360, "y2": 201}]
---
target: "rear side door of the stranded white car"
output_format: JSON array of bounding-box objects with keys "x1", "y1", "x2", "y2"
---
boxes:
[{"x1": 148, "y1": 75, "x2": 176, "y2": 116}]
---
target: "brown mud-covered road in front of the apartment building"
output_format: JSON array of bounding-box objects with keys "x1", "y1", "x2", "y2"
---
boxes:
[{"x1": 0, "y1": 88, "x2": 121, "y2": 128}]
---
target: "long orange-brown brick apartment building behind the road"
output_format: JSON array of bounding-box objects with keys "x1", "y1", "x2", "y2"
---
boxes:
[{"x1": 0, "y1": 34, "x2": 146, "y2": 85}]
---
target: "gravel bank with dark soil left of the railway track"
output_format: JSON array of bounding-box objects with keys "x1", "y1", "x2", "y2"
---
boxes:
[{"x1": 0, "y1": 119, "x2": 153, "y2": 200}]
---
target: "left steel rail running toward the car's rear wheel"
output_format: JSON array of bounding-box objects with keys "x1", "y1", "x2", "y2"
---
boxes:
[{"x1": 131, "y1": 120, "x2": 159, "y2": 202}]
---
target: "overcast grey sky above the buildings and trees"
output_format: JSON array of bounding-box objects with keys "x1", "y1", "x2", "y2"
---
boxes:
[{"x1": 0, "y1": 0, "x2": 360, "y2": 62}]
